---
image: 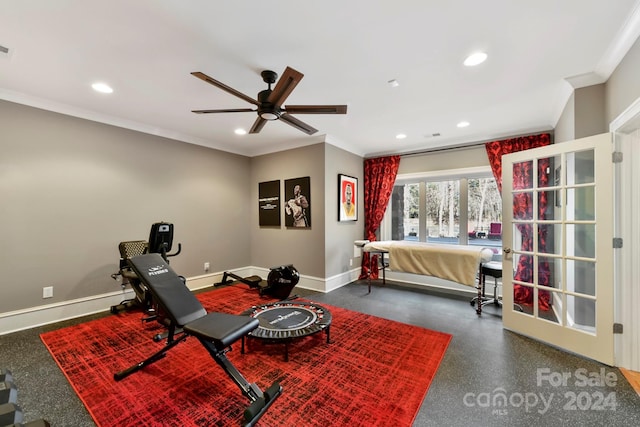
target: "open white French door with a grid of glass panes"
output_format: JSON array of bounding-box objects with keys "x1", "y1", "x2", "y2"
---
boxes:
[{"x1": 502, "y1": 134, "x2": 614, "y2": 365}]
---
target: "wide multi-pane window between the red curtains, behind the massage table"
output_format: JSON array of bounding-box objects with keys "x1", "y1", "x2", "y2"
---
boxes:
[{"x1": 381, "y1": 168, "x2": 502, "y2": 252}]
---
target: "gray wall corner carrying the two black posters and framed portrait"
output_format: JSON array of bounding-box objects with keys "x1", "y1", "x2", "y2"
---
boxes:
[{"x1": 251, "y1": 143, "x2": 364, "y2": 280}]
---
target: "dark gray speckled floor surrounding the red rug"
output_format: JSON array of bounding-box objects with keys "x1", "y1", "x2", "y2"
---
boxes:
[{"x1": 0, "y1": 282, "x2": 640, "y2": 427}]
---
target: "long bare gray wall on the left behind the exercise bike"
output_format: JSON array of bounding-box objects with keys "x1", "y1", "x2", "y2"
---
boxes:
[{"x1": 0, "y1": 101, "x2": 255, "y2": 313}]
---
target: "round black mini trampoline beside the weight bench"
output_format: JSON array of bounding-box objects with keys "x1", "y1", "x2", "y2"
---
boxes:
[{"x1": 241, "y1": 301, "x2": 331, "y2": 361}]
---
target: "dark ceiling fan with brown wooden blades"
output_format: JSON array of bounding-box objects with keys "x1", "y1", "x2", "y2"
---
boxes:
[{"x1": 191, "y1": 67, "x2": 347, "y2": 135}]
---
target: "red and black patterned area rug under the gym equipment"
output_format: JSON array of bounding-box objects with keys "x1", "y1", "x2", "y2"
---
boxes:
[{"x1": 41, "y1": 285, "x2": 451, "y2": 427}]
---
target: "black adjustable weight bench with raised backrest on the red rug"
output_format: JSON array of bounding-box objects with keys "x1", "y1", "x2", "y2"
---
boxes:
[{"x1": 114, "y1": 254, "x2": 282, "y2": 426}]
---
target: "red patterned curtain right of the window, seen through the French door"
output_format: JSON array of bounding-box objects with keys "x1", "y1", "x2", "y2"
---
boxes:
[{"x1": 486, "y1": 133, "x2": 551, "y2": 310}]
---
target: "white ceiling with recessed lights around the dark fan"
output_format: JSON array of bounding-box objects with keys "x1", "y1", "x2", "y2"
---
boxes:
[{"x1": 0, "y1": 0, "x2": 640, "y2": 156}]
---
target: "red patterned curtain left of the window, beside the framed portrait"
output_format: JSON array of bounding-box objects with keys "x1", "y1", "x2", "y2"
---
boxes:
[{"x1": 359, "y1": 156, "x2": 400, "y2": 279}]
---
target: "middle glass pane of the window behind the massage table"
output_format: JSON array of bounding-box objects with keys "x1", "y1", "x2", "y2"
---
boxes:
[{"x1": 426, "y1": 180, "x2": 460, "y2": 244}]
